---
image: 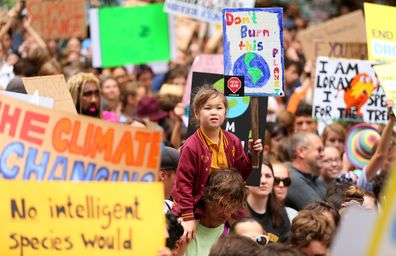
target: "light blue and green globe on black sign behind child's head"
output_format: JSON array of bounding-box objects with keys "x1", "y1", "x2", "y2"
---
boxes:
[{"x1": 213, "y1": 79, "x2": 250, "y2": 118}]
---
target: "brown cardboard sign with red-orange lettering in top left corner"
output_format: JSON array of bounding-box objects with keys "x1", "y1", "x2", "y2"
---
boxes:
[{"x1": 26, "y1": 0, "x2": 87, "y2": 39}]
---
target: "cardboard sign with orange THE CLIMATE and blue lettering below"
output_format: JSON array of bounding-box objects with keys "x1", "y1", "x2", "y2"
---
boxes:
[{"x1": 0, "y1": 95, "x2": 162, "y2": 182}]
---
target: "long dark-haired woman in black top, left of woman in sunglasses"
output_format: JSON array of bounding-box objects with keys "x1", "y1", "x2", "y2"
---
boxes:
[{"x1": 246, "y1": 159, "x2": 290, "y2": 242}]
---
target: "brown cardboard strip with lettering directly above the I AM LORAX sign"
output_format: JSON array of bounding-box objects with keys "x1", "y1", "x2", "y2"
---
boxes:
[{"x1": 313, "y1": 40, "x2": 368, "y2": 60}]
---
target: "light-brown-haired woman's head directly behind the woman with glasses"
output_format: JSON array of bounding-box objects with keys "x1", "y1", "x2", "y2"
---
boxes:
[{"x1": 322, "y1": 123, "x2": 347, "y2": 156}]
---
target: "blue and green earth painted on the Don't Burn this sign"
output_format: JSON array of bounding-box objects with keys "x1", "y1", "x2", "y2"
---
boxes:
[{"x1": 232, "y1": 52, "x2": 270, "y2": 88}]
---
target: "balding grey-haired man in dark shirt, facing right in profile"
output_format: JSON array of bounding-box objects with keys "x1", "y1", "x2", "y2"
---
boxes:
[{"x1": 286, "y1": 132, "x2": 327, "y2": 211}]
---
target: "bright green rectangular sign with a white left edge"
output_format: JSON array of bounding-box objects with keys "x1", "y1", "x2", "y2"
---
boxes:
[{"x1": 89, "y1": 4, "x2": 171, "y2": 67}]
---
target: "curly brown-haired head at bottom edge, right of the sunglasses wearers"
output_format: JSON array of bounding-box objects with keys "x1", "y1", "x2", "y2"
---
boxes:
[{"x1": 289, "y1": 210, "x2": 336, "y2": 256}]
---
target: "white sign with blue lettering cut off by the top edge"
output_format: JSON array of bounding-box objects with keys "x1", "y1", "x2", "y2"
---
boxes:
[{"x1": 165, "y1": 0, "x2": 255, "y2": 23}]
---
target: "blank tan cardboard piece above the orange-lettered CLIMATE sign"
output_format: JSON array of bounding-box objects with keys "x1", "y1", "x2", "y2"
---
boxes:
[{"x1": 22, "y1": 75, "x2": 77, "y2": 114}]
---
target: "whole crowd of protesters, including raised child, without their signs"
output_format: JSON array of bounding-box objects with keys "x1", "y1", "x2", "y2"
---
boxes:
[{"x1": 0, "y1": 0, "x2": 396, "y2": 256}]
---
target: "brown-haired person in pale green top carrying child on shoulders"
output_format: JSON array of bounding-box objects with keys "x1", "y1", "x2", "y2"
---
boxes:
[{"x1": 178, "y1": 169, "x2": 246, "y2": 256}]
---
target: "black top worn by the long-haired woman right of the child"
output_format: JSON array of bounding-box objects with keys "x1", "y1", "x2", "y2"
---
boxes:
[{"x1": 248, "y1": 204, "x2": 290, "y2": 242}]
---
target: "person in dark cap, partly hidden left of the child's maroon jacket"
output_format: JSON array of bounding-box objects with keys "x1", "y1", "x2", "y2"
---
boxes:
[{"x1": 159, "y1": 146, "x2": 180, "y2": 212}]
